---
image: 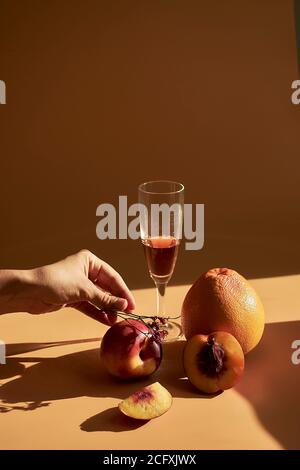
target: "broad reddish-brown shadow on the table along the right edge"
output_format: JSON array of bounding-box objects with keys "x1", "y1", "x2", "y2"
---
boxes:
[{"x1": 236, "y1": 321, "x2": 300, "y2": 449}]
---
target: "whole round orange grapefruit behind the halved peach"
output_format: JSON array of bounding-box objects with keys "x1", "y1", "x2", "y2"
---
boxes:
[{"x1": 181, "y1": 268, "x2": 265, "y2": 354}]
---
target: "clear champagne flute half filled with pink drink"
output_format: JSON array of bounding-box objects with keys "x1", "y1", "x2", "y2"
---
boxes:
[{"x1": 138, "y1": 181, "x2": 184, "y2": 341}]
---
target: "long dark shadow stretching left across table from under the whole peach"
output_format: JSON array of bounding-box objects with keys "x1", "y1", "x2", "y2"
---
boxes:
[{"x1": 0, "y1": 340, "x2": 211, "y2": 412}]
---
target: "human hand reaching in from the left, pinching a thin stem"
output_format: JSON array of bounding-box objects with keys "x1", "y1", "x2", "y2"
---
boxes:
[{"x1": 0, "y1": 250, "x2": 135, "y2": 325}]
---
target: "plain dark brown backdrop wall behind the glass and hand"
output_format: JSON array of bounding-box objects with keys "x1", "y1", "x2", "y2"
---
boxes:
[{"x1": 0, "y1": 0, "x2": 300, "y2": 287}]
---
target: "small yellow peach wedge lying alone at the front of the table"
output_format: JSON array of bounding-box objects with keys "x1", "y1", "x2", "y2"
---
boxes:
[{"x1": 119, "y1": 382, "x2": 173, "y2": 420}]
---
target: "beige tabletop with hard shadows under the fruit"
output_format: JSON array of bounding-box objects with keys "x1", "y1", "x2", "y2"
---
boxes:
[{"x1": 0, "y1": 275, "x2": 300, "y2": 450}]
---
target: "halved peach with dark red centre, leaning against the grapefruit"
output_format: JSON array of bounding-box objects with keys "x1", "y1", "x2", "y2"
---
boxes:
[{"x1": 183, "y1": 331, "x2": 244, "y2": 393}]
